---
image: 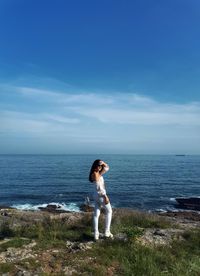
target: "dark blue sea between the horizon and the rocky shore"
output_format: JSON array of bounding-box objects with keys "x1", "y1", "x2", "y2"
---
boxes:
[{"x1": 0, "y1": 154, "x2": 200, "y2": 211}]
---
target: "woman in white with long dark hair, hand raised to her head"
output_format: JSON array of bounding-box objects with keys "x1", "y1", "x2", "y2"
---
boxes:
[{"x1": 89, "y1": 159, "x2": 113, "y2": 240}]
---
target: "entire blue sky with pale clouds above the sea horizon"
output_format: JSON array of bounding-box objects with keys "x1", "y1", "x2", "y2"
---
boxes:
[{"x1": 0, "y1": 0, "x2": 200, "y2": 154}]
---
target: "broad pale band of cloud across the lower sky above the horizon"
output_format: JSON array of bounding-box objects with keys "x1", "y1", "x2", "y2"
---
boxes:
[{"x1": 0, "y1": 81, "x2": 200, "y2": 152}]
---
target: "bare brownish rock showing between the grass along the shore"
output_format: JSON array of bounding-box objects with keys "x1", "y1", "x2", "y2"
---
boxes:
[{"x1": 0, "y1": 205, "x2": 200, "y2": 276}]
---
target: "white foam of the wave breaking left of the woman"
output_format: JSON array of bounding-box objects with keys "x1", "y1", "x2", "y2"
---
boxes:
[{"x1": 11, "y1": 202, "x2": 80, "y2": 212}]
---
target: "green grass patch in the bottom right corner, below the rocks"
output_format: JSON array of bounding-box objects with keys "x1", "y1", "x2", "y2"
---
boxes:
[{"x1": 82, "y1": 231, "x2": 200, "y2": 276}]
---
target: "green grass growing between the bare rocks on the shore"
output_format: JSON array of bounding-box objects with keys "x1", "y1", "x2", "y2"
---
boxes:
[{"x1": 0, "y1": 210, "x2": 200, "y2": 276}]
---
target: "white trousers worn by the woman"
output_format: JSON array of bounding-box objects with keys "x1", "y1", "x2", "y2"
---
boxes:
[{"x1": 93, "y1": 196, "x2": 112, "y2": 234}]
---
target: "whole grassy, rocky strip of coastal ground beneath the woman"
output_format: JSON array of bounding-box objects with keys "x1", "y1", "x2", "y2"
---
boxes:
[{"x1": 0, "y1": 209, "x2": 200, "y2": 276}]
